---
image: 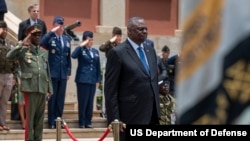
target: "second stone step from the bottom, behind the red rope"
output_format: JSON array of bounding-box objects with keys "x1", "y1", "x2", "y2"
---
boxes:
[{"x1": 6, "y1": 117, "x2": 107, "y2": 130}]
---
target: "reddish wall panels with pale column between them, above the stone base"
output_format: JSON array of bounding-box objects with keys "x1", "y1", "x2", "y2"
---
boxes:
[{"x1": 40, "y1": 0, "x2": 178, "y2": 36}]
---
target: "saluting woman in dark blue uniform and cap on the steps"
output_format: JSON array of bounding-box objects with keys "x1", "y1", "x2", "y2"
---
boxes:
[{"x1": 71, "y1": 31, "x2": 101, "y2": 128}]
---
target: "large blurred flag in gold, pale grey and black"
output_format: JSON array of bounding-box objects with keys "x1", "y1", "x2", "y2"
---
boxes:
[{"x1": 176, "y1": 0, "x2": 250, "y2": 124}]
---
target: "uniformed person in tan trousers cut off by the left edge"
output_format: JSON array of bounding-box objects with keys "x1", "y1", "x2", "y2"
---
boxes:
[{"x1": 0, "y1": 21, "x2": 14, "y2": 131}]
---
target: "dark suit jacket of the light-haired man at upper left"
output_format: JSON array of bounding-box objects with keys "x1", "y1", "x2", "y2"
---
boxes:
[{"x1": 18, "y1": 19, "x2": 47, "y2": 41}]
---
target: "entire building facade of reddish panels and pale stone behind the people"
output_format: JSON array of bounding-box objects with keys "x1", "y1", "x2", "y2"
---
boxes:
[{"x1": 6, "y1": 0, "x2": 180, "y2": 101}]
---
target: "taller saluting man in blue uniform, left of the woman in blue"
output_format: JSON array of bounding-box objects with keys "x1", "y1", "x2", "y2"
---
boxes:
[{"x1": 40, "y1": 16, "x2": 71, "y2": 129}]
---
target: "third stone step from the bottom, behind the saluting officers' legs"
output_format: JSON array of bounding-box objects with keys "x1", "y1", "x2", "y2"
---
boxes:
[{"x1": 6, "y1": 110, "x2": 102, "y2": 119}]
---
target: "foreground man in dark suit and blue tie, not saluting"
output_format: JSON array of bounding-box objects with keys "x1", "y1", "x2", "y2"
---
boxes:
[{"x1": 104, "y1": 17, "x2": 160, "y2": 141}]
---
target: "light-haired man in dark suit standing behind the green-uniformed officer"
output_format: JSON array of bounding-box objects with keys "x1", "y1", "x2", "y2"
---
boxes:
[{"x1": 18, "y1": 4, "x2": 47, "y2": 41}]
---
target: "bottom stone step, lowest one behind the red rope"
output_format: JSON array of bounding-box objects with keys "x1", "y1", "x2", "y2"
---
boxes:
[{"x1": 0, "y1": 128, "x2": 113, "y2": 141}]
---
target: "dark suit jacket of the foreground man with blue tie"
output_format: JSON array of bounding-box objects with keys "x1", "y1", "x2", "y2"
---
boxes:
[{"x1": 104, "y1": 40, "x2": 160, "y2": 124}]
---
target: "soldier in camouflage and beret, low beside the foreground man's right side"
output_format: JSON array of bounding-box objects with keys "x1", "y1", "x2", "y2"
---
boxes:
[{"x1": 159, "y1": 81, "x2": 175, "y2": 125}]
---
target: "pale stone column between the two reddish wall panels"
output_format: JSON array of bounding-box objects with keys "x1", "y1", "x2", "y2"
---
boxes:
[{"x1": 96, "y1": 0, "x2": 126, "y2": 33}]
